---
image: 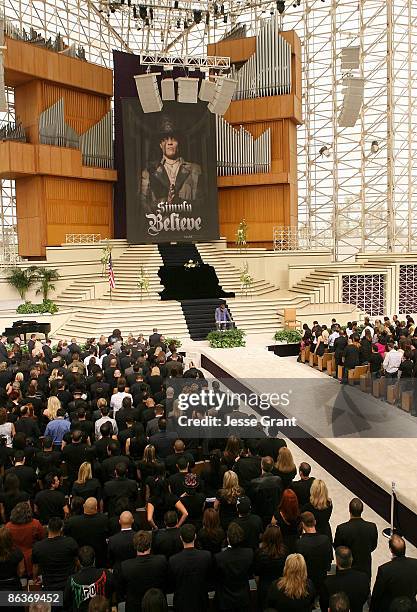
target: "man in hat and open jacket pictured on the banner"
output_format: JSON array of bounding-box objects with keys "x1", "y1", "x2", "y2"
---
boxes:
[{"x1": 141, "y1": 115, "x2": 201, "y2": 212}]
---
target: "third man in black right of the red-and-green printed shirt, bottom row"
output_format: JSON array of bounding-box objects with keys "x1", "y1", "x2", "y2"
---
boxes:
[{"x1": 214, "y1": 523, "x2": 253, "y2": 612}]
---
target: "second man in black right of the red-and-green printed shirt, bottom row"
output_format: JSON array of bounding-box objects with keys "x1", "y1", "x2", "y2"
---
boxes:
[{"x1": 169, "y1": 524, "x2": 212, "y2": 612}]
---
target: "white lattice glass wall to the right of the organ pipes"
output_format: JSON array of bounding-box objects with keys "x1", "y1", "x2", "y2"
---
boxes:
[{"x1": 284, "y1": 0, "x2": 417, "y2": 260}]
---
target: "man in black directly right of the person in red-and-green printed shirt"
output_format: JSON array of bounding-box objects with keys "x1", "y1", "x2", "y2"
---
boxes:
[{"x1": 115, "y1": 531, "x2": 168, "y2": 612}]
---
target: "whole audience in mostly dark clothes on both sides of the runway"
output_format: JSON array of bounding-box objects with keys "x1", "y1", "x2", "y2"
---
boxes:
[{"x1": 0, "y1": 328, "x2": 417, "y2": 612}]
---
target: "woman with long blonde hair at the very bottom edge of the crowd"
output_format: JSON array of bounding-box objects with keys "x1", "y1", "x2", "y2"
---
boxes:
[{"x1": 267, "y1": 554, "x2": 315, "y2": 612}]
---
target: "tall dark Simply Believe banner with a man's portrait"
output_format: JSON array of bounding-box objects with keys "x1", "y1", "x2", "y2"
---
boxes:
[{"x1": 122, "y1": 98, "x2": 219, "y2": 243}]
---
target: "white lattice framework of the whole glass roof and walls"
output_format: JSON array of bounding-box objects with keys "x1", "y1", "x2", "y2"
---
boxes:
[{"x1": 0, "y1": 0, "x2": 417, "y2": 261}]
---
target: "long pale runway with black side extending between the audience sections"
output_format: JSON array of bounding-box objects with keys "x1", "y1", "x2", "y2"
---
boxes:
[{"x1": 198, "y1": 343, "x2": 417, "y2": 544}]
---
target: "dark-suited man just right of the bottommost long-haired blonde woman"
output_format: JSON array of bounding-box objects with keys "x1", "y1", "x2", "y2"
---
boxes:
[{"x1": 320, "y1": 546, "x2": 368, "y2": 612}]
